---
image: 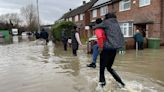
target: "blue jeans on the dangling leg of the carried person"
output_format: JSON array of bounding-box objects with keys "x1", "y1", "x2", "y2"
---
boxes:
[{"x1": 92, "y1": 44, "x2": 99, "y2": 64}]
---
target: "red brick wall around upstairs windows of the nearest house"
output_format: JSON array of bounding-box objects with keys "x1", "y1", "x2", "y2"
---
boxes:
[{"x1": 114, "y1": 0, "x2": 161, "y2": 37}]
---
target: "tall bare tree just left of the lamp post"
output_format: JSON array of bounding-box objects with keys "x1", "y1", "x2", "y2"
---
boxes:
[{"x1": 21, "y1": 4, "x2": 38, "y2": 32}]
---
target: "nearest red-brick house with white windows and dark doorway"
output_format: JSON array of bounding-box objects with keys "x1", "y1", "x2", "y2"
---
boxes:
[{"x1": 90, "y1": 0, "x2": 164, "y2": 48}]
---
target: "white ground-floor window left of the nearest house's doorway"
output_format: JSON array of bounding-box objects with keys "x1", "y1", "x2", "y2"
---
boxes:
[{"x1": 120, "y1": 23, "x2": 133, "y2": 37}]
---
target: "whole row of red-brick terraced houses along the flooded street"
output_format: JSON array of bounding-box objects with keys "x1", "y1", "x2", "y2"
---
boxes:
[{"x1": 62, "y1": 0, "x2": 164, "y2": 49}]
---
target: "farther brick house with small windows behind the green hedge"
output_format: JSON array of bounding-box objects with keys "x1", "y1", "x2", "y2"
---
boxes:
[{"x1": 60, "y1": 0, "x2": 97, "y2": 39}]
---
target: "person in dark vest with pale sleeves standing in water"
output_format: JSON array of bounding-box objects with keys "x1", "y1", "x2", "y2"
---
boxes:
[{"x1": 71, "y1": 26, "x2": 82, "y2": 56}]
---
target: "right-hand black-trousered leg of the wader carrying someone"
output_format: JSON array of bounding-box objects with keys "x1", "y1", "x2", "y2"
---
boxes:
[{"x1": 106, "y1": 50, "x2": 125, "y2": 87}]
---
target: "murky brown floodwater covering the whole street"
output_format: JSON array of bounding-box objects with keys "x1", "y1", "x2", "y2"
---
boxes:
[{"x1": 0, "y1": 37, "x2": 164, "y2": 92}]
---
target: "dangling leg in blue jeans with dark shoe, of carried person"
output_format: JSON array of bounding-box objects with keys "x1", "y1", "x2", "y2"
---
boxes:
[{"x1": 87, "y1": 44, "x2": 99, "y2": 68}]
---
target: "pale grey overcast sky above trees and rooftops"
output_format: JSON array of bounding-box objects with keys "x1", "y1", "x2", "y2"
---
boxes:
[{"x1": 0, "y1": 0, "x2": 90, "y2": 24}]
